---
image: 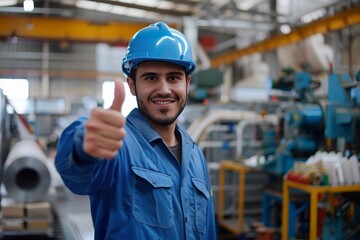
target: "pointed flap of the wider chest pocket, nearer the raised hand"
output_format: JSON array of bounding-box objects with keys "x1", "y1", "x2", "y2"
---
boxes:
[{"x1": 132, "y1": 167, "x2": 173, "y2": 188}]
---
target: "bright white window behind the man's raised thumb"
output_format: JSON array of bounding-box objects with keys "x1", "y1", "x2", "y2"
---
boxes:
[{"x1": 102, "y1": 81, "x2": 137, "y2": 117}]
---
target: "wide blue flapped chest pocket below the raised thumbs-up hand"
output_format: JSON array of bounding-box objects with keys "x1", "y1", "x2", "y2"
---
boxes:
[{"x1": 132, "y1": 167, "x2": 174, "y2": 228}]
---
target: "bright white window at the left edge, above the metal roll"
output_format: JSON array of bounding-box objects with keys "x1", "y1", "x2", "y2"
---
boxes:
[{"x1": 0, "y1": 78, "x2": 29, "y2": 114}]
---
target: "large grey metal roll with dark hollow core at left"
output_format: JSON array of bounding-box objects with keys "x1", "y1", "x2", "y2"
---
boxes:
[{"x1": 3, "y1": 140, "x2": 51, "y2": 202}]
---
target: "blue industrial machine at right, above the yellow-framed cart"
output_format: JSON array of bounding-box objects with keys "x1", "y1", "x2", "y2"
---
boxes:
[{"x1": 264, "y1": 72, "x2": 360, "y2": 176}]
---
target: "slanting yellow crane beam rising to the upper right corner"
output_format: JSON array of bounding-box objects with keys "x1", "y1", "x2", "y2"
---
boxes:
[{"x1": 210, "y1": 7, "x2": 360, "y2": 68}]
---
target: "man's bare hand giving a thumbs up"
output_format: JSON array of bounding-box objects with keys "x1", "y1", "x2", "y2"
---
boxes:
[{"x1": 83, "y1": 80, "x2": 125, "y2": 159}]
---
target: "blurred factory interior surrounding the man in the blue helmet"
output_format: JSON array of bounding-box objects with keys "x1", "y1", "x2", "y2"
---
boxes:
[{"x1": 0, "y1": 0, "x2": 360, "y2": 240}]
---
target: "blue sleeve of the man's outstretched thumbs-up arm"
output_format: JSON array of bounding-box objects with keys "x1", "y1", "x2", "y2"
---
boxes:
[{"x1": 55, "y1": 117, "x2": 117, "y2": 195}]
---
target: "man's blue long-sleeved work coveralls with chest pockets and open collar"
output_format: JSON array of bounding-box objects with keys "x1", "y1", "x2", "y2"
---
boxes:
[{"x1": 55, "y1": 108, "x2": 216, "y2": 240}]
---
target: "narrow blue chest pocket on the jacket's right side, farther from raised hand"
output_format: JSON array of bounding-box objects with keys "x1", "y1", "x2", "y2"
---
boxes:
[{"x1": 191, "y1": 178, "x2": 210, "y2": 233}]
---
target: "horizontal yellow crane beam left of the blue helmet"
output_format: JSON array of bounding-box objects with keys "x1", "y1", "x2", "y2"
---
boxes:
[{"x1": 0, "y1": 15, "x2": 148, "y2": 43}]
